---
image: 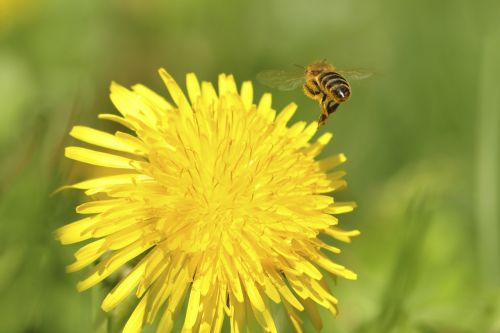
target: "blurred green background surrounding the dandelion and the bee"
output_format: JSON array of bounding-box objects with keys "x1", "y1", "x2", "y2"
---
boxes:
[{"x1": 0, "y1": 0, "x2": 500, "y2": 333}]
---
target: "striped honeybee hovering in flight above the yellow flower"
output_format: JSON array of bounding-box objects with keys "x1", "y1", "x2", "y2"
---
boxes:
[{"x1": 257, "y1": 60, "x2": 371, "y2": 127}]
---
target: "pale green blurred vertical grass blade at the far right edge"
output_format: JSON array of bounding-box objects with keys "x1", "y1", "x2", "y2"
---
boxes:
[{"x1": 476, "y1": 34, "x2": 500, "y2": 287}]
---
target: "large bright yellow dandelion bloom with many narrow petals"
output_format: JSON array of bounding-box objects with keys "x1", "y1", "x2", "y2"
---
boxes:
[{"x1": 56, "y1": 69, "x2": 359, "y2": 332}]
